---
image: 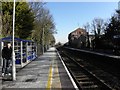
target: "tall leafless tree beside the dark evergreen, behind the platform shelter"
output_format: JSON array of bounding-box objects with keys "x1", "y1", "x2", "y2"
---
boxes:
[{"x1": 30, "y1": 2, "x2": 55, "y2": 44}]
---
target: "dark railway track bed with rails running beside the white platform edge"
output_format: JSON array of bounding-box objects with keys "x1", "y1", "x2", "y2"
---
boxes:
[{"x1": 56, "y1": 47, "x2": 120, "y2": 90}]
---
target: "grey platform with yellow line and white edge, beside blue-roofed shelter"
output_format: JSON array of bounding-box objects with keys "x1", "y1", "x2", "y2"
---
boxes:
[{"x1": 2, "y1": 47, "x2": 77, "y2": 90}]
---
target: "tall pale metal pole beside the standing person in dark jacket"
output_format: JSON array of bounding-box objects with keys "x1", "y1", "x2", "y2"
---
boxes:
[{"x1": 12, "y1": 0, "x2": 16, "y2": 81}]
